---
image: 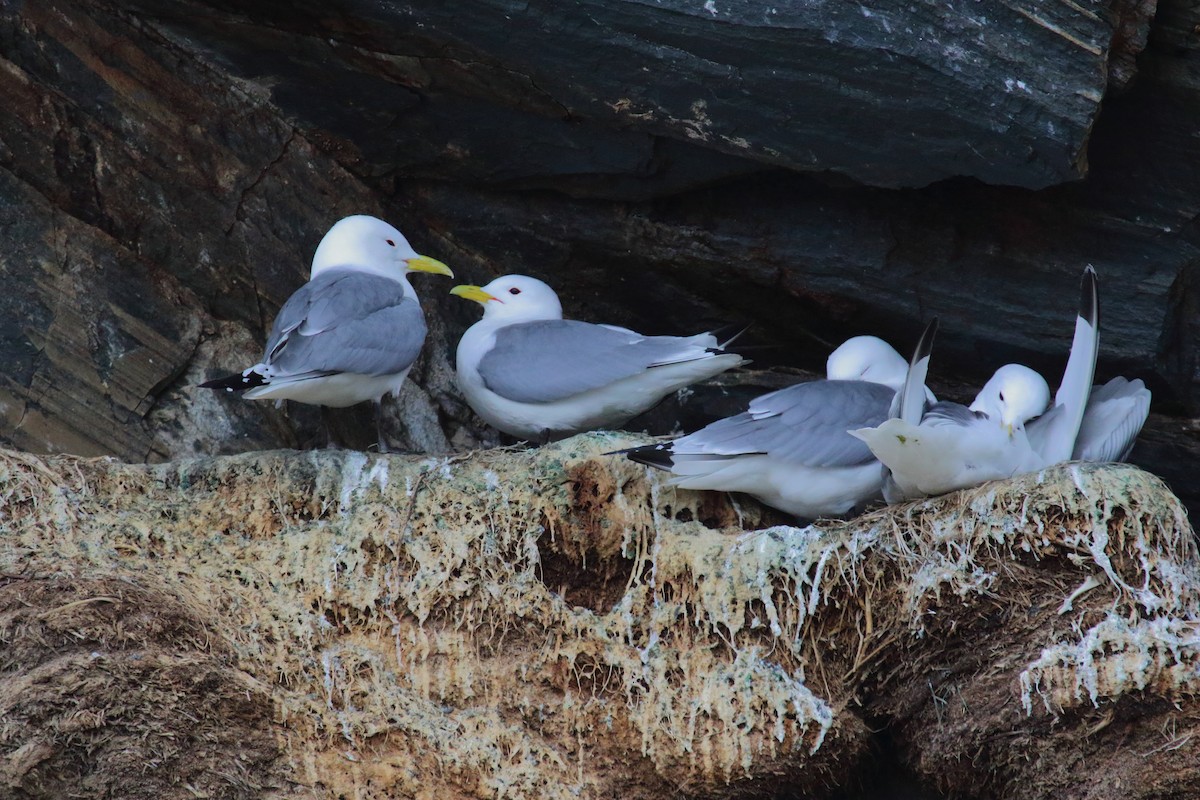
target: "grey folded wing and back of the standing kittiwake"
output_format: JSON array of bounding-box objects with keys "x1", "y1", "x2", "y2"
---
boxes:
[{"x1": 263, "y1": 270, "x2": 425, "y2": 377}]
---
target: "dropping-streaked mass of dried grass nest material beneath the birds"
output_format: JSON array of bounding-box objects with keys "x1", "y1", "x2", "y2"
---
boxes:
[{"x1": 0, "y1": 434, "x2": 1200, "y2": 799}]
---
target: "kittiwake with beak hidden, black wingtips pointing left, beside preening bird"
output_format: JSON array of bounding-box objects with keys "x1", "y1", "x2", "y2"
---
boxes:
[{"x1": 622, "y1": 336, "x2": 906, "y2": 519}]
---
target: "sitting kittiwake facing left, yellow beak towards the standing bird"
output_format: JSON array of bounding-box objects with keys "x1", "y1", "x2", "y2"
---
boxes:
[{"x1": 451, "y1": 275, "x2": 745, "y2": 441}]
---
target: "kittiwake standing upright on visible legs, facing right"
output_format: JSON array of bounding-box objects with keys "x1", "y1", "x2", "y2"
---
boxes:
[{"x1": 200, "y1": 215, "x2": 454, "y2": 452}]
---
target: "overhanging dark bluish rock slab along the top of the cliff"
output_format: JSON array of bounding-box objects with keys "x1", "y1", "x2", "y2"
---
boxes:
[{"x1": 136, "y1": 0, "x2": 1128, "y2": 188}]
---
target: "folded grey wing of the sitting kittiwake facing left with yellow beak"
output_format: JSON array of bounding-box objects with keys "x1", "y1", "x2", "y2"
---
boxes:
[{"x1": 479, "y1": 319, "x2": 709, "y2": 403}]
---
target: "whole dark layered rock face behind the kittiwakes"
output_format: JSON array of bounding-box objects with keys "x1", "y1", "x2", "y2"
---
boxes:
[{"x1": 0, "y1": 0, "x2": 1200, "y2": 507}]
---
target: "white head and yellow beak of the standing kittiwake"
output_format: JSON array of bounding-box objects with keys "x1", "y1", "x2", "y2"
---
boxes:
[{"x1": 311, "y1": 213, "x2": 454, "y2": 278}]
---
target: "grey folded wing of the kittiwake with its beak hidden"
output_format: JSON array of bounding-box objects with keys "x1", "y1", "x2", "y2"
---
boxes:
[{"x1": 672, "y1": 380, "x2": 894, "y2": 467}]
